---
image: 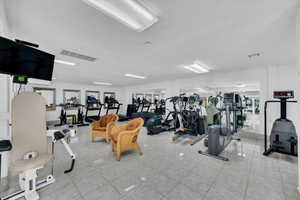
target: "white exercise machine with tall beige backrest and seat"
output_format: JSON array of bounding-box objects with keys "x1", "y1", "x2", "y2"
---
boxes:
[{"x1": 0, "y1": 92, "x2": 55, "y2": 200}]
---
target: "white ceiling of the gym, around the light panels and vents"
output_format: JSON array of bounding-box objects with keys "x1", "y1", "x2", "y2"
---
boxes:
[{"x1": 5, "y1": 0, "x2": 299, "y2": 85}]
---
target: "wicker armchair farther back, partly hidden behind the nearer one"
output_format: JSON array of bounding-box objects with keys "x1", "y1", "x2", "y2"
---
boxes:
[{"x1": 91, "y1": 114, "x2": 119, "y2": 143}]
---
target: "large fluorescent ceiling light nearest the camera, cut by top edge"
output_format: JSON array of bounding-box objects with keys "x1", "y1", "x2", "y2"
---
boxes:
[{"x1": 83, "y1": 0, "x2": 158, "y2": 32}]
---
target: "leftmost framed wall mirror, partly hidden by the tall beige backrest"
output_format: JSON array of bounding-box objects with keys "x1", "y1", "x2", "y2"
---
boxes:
[{"x1": 33, "y1": 87, "x2": 56, "y2": 111}]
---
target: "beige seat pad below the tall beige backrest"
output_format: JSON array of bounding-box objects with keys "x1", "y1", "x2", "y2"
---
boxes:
[{"x1": 10, "y1": 154, "x2": 54, "y2": 176}]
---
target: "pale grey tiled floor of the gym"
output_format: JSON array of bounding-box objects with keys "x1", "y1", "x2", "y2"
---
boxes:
[{"x1": 1, "y1": 127, "x2": 300, "y2": 200}]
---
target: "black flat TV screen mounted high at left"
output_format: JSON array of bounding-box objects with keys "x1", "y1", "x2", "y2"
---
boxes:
[{"x1": 0, "y1": 37, "x2": 55, "y2": 81}]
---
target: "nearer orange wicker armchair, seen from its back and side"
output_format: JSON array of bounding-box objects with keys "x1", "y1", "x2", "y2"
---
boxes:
[{"x1": 110, "y1": 118, "x2": 144, "y2": 161}]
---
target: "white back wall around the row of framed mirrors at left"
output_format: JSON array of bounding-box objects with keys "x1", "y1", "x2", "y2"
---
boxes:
[{"x1": 26, "y1": 82, "x2": 125, "y2": 121}]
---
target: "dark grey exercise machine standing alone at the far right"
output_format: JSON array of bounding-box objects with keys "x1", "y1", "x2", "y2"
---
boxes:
[{"x1": 263, "y1": 91, "x2": 298, "y2": 156}]
